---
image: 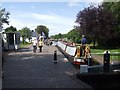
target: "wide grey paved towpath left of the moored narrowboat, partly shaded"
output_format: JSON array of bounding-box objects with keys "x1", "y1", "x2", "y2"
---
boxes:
[{"x1": 3, "y1": 46, "x2": 92, "y2": 88}]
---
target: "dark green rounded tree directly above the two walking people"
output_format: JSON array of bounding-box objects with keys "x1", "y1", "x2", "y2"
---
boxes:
[{"x1": 35, "y1": 25, "x2": 49, "y2": 38}]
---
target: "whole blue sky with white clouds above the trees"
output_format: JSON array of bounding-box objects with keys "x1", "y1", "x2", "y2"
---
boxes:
[{"x1": 1, "y1": 0, "x2": 104, "y2": 36}]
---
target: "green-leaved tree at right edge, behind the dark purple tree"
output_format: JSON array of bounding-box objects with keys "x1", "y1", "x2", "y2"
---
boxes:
[{"x1": 103, "y1": 2, "x2": 120, "y2": 46}]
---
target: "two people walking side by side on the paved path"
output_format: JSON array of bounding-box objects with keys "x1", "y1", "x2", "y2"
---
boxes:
[{"x1": 32, "y1": 38, "x2": 43, "y2": 53}]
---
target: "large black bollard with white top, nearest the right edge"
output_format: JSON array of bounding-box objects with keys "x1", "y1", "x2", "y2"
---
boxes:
[{"x1": 103, "y1": 51, "x2": 110, "y2": 72}]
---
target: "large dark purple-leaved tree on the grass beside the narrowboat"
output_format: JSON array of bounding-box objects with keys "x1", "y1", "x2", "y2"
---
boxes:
[{"x1": 76, "y1": 5, "x2": 115, "y2": 46}]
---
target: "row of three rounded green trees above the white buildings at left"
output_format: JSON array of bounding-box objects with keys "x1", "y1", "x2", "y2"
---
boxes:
[{"x1": 1, "y1": 25, "x2": 49, "y2": 44}]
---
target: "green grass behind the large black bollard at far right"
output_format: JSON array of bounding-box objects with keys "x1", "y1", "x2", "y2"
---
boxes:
[{"x1": 91, "y1": 48, "x2": 120, "y2": 61}]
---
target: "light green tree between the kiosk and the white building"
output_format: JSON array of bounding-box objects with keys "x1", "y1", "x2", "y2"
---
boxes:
[{"x1": 19, "y1": 27, "x2": 31, "y2": 44}]
